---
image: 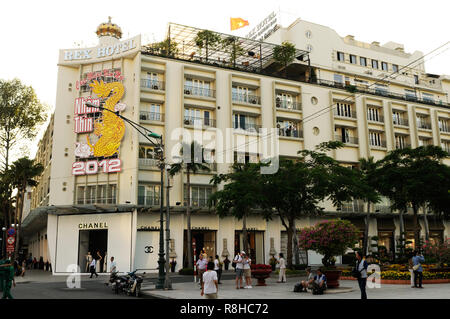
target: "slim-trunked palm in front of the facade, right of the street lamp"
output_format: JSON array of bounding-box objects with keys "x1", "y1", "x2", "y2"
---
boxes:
[{"x1": 169, "y1": 141, "x2": 210, "y2": 268}]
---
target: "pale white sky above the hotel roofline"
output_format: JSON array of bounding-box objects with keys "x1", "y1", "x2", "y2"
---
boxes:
[{"x1": 0, "y1": 0, "x2": 450, "y2": 157}]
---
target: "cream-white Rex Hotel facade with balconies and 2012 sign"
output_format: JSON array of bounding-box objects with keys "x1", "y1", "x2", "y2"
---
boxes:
[{"x1": 23, "y1": 19, "x2": 450, "y2": 273}]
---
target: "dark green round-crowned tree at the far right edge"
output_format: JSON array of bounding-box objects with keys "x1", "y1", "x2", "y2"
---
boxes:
[{"x1": 374, "y1": 145, "x2": 450, "y2": 249}]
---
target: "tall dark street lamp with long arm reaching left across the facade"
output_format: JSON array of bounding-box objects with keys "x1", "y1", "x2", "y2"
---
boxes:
[{"x1": 86, "y1": 102, "x2": 165, "y2": 289}]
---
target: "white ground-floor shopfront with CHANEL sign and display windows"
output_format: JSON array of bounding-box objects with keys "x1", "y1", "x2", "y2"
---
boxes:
[{"x1": 22, "y1": 205, "x2": 450, "y2": 273}]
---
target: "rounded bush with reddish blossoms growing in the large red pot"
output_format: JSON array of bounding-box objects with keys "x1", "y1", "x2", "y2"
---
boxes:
[{"x1": 298, "y1": 219, "x2": 359, "y2": 267}]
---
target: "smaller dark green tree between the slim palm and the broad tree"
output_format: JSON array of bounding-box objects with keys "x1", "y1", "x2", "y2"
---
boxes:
[{"x1": 210, "y1": 163, "x2": 262, "y2": 253}]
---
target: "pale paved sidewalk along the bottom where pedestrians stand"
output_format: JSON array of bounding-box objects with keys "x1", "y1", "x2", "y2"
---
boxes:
[{"x1": 142, "y1": 277, "x2": 450, "y2": 299}]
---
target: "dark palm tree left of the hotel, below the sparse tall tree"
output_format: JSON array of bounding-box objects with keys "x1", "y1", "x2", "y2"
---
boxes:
[{"x1": 10, "y1": 157, "x2": 44, "y2": 256}]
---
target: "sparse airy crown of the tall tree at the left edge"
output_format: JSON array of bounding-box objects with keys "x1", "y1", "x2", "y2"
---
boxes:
[{"x1": 0, "y1": 79, "x2": 47, "y2": 171}]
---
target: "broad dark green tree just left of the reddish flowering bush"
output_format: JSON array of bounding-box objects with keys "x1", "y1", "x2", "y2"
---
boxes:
[{"x1": 262, "y1": 141, "x2": 358, "y2": 268}]
